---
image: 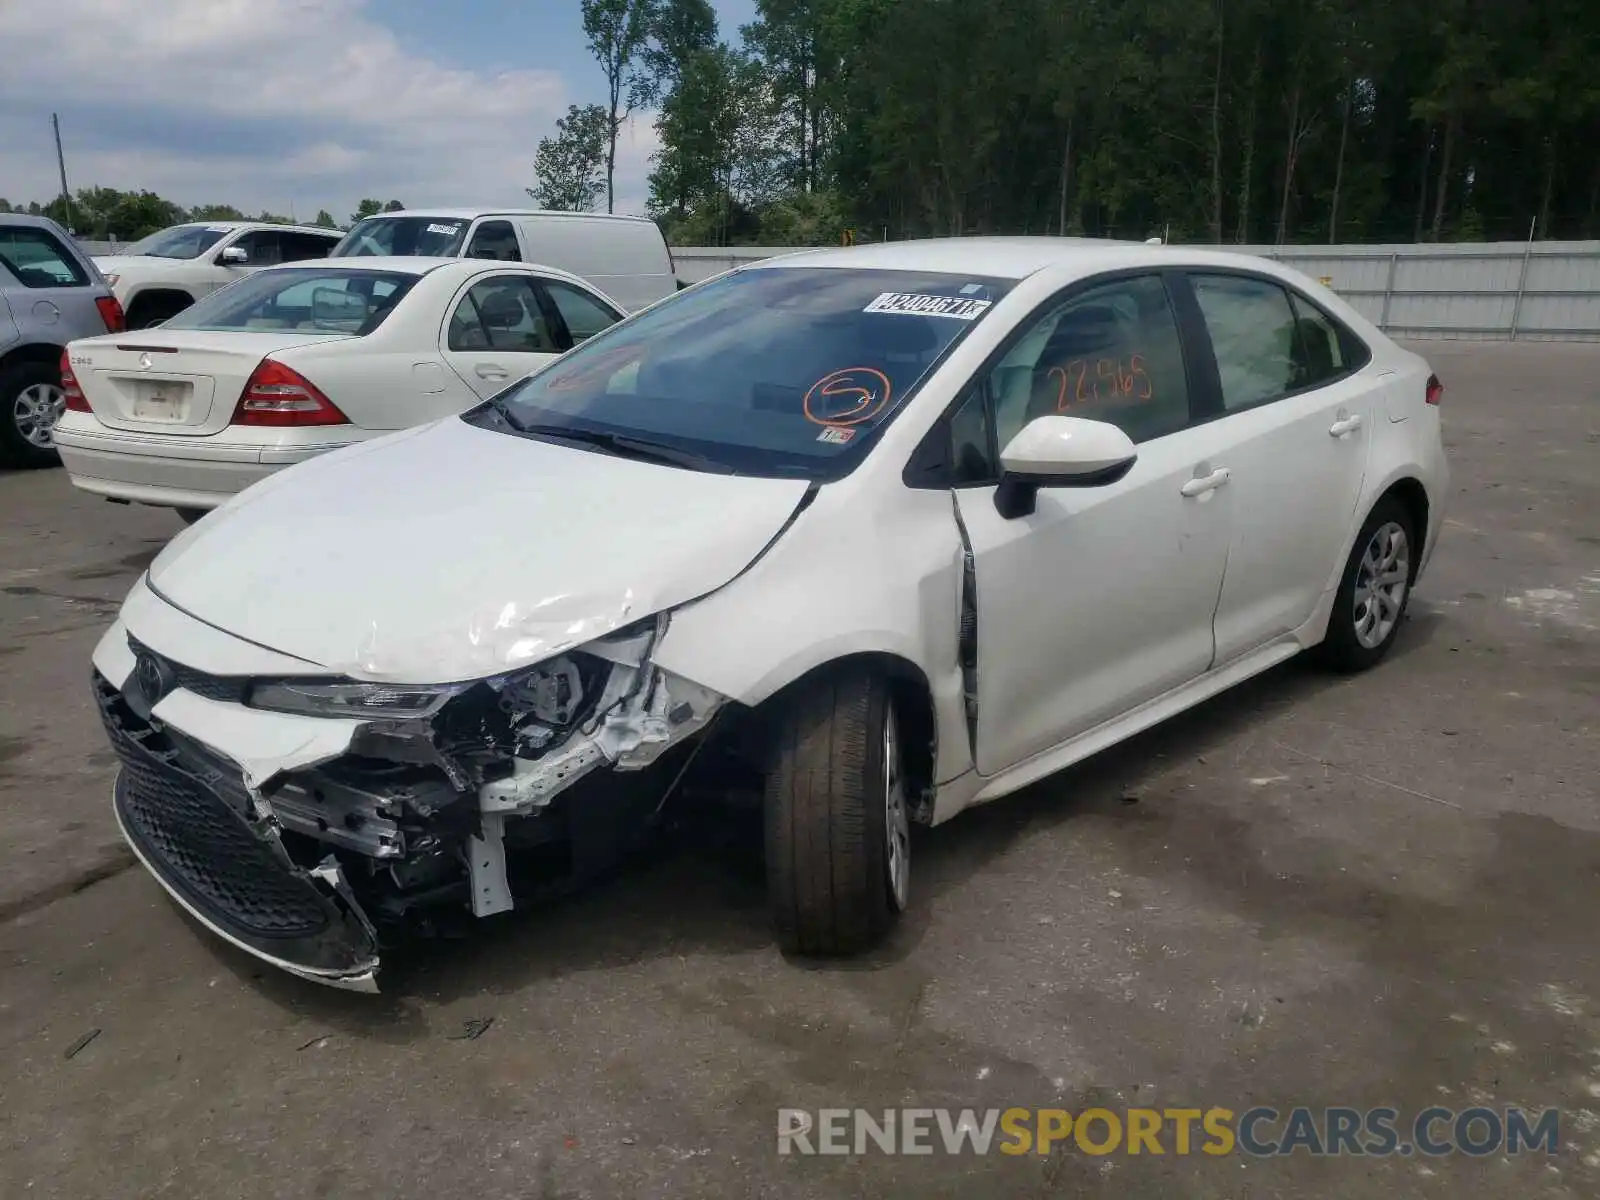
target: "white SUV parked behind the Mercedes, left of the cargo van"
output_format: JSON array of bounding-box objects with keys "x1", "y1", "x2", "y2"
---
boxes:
[{"x1": 94, "y1": 221, "x2": 344, "y2": 330}]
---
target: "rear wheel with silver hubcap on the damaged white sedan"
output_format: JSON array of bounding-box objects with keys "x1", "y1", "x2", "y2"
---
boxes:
[{"x1": 1318, "y1": 498, "x2": 1418, "y2": 672}]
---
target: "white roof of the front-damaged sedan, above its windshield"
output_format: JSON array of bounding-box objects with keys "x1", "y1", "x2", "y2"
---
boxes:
[{"x1": 750, "y1": 237, "x2": 1173, "y2": 280}]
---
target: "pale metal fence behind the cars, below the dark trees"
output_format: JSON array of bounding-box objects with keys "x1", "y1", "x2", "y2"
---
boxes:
[{"x1": 672, "y1": 242, "x2": 1600, "y2": 341}]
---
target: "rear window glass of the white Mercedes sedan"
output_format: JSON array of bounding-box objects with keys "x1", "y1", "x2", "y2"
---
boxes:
[{"x1": 162, "y1": 269, "x2": 418, "y2": 336}]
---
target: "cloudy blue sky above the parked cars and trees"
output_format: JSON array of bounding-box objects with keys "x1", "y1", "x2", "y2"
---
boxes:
[{"x1": 0, "y1": 0, "x2": 755, "y2": 227}]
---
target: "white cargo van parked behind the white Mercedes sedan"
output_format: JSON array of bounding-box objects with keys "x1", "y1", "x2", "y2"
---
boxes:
[{"x1": 330, "y1": 208, "x2": 678, "y2": 312}]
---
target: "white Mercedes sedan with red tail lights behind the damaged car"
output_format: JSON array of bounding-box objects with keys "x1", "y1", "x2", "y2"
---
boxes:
[{"x1": 54, "y1": 258, "x2": 622, "y2": 522}]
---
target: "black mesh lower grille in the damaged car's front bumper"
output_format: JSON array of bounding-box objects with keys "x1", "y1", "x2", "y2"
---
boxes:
[{"x1": 96, "y1": 680, "x2": 331, "y2": 939}]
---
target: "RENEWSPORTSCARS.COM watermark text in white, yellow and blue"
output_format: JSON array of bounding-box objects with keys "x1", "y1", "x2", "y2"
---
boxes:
[{"x1": 778, "y1": 1106, "x2": 1560, "y2": 1158}]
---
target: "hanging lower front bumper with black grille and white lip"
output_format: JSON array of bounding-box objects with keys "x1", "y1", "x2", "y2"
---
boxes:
[{"x1": 94, "y1": 674, "x2": 378, "y2": 992}]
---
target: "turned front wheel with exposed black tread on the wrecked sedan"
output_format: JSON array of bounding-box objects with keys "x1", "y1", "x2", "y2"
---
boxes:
[{"x1": 765, "y1": 670, "x2": 909, "y2": 955}]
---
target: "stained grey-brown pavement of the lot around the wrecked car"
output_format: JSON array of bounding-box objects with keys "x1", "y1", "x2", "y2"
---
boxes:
[{"x1": 0, "y1": 344, "x2": 1600, "y2": 1198}]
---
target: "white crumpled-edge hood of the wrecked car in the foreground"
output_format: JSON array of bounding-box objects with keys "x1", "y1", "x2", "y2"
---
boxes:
[{"x1": 150, "y1": 418, "x2": 806, "y2": 683}]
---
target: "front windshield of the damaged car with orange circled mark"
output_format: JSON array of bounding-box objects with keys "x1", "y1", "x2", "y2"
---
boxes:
[{"x1": 467, "y1": 267, "x2": 1011, "y2": 480}]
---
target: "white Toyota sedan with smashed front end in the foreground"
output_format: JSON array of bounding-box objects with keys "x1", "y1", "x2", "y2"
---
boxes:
[{"x1": 94, "y1": 238, "x2": 1446, "y2": 989}]
